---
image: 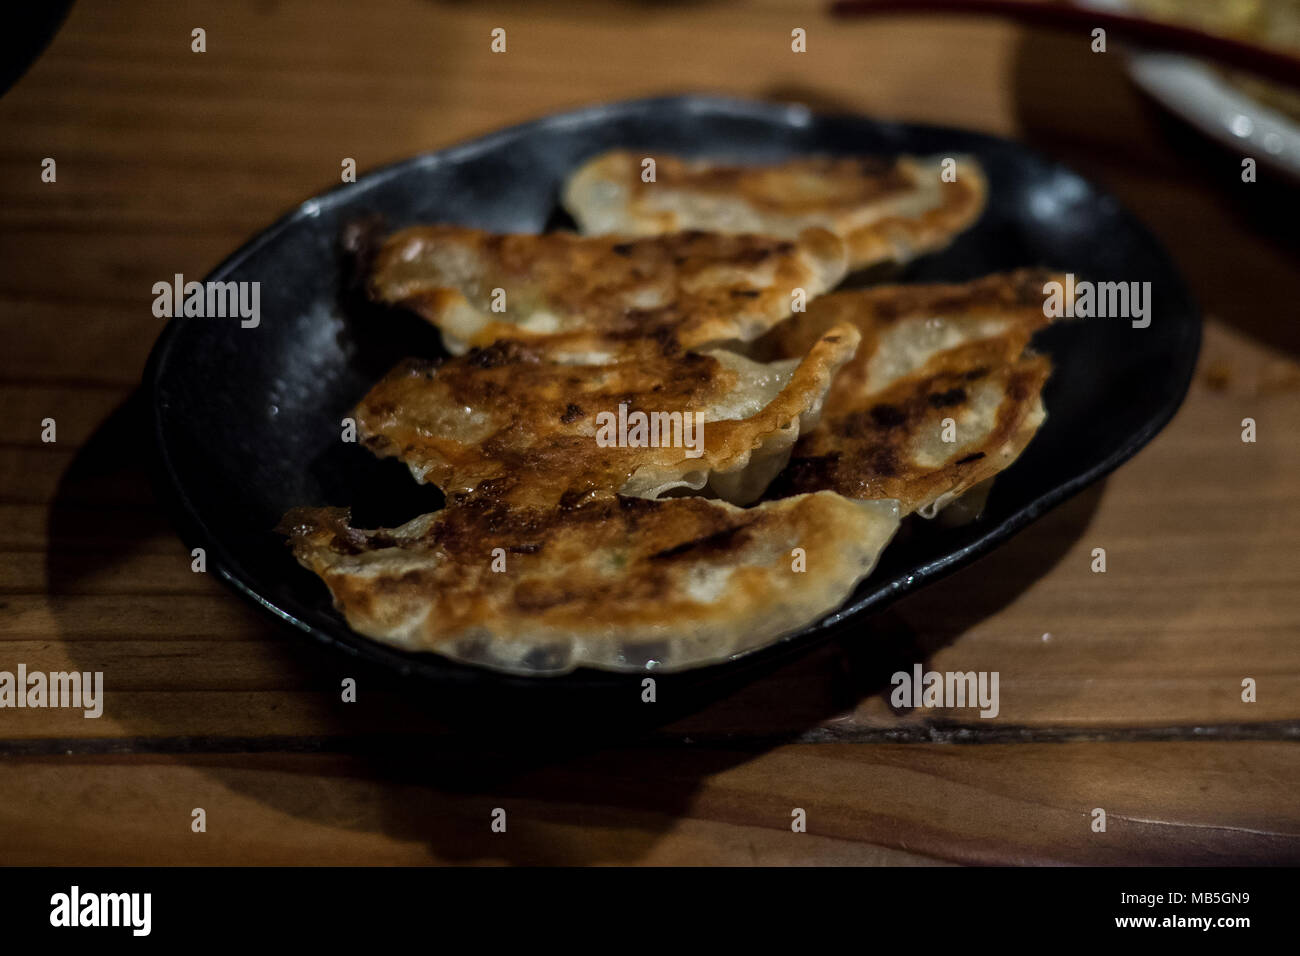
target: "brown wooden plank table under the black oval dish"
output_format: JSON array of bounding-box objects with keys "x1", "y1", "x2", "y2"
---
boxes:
[{"x1": 0, "y1": 0, "x2": 1300, "y2": 864}]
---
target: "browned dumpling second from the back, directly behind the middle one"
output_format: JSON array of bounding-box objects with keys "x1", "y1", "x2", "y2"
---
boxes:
[{"x1": 371, "y1": 225, "x2": 846, "y2": 355}]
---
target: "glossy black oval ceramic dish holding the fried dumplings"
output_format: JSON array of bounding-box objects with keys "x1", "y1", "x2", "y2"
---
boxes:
[{"x1": 146, "y1": 96, "x2": 1200, "y2": 698}]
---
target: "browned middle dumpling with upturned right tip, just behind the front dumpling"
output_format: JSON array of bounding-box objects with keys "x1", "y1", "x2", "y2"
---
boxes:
[{"x1": 356, "y1": 325, "x2": 859, "y2": 506}]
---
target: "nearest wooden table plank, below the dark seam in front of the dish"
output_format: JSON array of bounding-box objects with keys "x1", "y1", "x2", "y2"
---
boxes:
[{"x1": 0, "y1": 743, "x2": 1300, "y2": 865}]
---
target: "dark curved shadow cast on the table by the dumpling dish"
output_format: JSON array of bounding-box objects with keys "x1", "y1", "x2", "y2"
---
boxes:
[{"x1": 47, "y1": 395, "x2": 1101, "y2": 862}]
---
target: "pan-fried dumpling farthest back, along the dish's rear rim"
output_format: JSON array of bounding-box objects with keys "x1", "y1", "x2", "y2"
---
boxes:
[{"x1": 563, "y1": 150, "x2": 988, "y2": 269}]
